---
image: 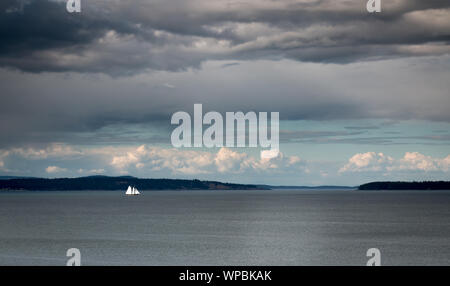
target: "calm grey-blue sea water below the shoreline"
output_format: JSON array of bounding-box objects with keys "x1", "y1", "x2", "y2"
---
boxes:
[{"x1": 0, "y1": 190, "x2": 450, "y2": 265}]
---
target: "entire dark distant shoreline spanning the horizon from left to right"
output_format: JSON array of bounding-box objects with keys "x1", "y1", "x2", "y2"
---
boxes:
[{"x1": 0, "y1": 176, "x2": 450, "y2": 191}]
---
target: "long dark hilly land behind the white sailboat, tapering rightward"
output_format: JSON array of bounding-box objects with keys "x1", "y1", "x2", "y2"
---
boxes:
[{"x1": 0, "y1": 176, "x2": 263, "y2": 191}]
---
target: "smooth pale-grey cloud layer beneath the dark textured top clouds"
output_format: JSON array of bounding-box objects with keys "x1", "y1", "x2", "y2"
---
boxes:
[{"x1": 0, "y1": 50, "x2": 450, "y2": 149}]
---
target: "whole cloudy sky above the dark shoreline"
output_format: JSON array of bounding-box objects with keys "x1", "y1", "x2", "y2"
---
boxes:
[{"x1": 0, "y1": 0, "x2": 450, "y2": 186}]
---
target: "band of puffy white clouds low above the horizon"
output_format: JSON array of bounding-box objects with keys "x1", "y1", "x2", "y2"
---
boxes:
[{"x1": 0, "y1": 144, "x2": 450, "y2": 185}]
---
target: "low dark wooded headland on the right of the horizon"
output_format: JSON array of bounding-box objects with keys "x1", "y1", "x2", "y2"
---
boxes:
[{"x1": 358, "y1": 181, "x2": 450, "y2": 190}]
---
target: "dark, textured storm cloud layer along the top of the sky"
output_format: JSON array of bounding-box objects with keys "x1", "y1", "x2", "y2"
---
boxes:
[{"x1": 0, "y1": 0, "x2": 450, "y2": 75}]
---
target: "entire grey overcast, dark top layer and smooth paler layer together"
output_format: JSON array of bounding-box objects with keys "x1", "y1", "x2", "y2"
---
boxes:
[{"x1": 0, "y1": 0, "x2": 450, "y2": 148}]
